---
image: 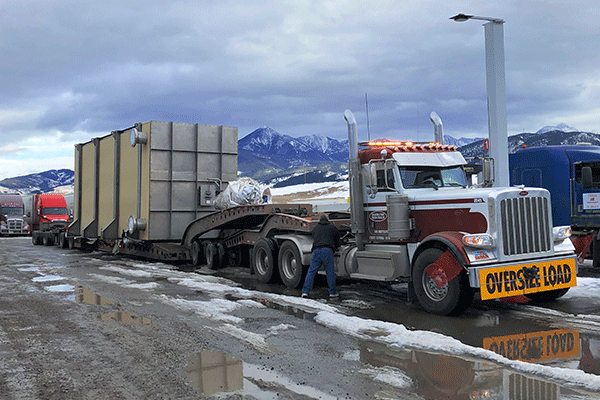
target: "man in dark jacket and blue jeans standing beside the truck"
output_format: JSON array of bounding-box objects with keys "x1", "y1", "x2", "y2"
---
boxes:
[{"x1": 302, "y1": 214, "x2": 340, "y2": 297}]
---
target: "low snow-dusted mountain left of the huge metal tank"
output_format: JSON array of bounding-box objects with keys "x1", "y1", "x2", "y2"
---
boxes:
[{"x1": 0, "y1": 169, "x2": 75, "y2": 194}]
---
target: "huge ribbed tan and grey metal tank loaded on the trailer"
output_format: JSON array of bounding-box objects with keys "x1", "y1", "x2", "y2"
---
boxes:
[{"x1": 69, "y1": 121, "x2": 238, "y2": 241}]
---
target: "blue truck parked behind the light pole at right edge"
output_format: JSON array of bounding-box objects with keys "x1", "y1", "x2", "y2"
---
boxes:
[{"x1": 509, "y1": 144, "x2": 600, "y2": 268}]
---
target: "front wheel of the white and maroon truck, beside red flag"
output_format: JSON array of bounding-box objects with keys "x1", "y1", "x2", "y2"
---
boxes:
[{"x1": 413, "y1": 248, "x2": 473, "y2": 315}]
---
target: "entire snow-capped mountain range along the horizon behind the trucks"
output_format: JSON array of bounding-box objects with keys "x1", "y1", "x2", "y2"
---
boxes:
[{"x1": 0, "y1": 124, "x2": 600, "y2": 194}]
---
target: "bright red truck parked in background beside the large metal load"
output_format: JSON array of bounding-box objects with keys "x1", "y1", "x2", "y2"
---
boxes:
[{"x1": 24, "y1": 193, "x2": 71, "y2": 247}]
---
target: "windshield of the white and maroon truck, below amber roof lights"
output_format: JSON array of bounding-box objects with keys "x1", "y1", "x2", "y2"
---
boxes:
[{"x1": 398, "y1": 166, "x2": 467, "y2": 189}]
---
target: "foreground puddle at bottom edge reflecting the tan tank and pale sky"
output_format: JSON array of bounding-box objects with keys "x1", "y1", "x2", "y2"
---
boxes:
[{"x1": 185, "y1": 350, "x2": 335, "y2": 400}]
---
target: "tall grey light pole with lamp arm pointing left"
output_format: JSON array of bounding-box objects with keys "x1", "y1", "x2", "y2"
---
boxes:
[{"x1": 450, "y1": 14, "x2": 509, "y2": 186}]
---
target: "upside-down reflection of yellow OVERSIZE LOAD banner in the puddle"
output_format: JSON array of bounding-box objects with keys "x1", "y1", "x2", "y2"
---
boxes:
[{"x1": 483, "y1": 329, "x2": 579, "y2": 362}]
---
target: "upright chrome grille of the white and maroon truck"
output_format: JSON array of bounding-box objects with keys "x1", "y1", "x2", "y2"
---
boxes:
[{"x1": 500, "y1": 197, "x2": 552, "y2": 256}]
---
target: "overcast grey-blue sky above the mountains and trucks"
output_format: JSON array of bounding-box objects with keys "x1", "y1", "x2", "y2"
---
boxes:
[{"x1": 0, "y1": 0, "x2": 600, "y2": 180}]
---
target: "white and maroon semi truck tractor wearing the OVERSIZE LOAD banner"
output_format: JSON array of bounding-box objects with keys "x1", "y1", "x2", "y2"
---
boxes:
[{"x1": 345, "y1": 111, "x2": 577, "y2": 315}]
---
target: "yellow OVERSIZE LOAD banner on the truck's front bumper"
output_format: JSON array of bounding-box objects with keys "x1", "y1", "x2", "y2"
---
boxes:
[{"x1": 479, "y1": 257, "x2": 577, "y2": 300}]
